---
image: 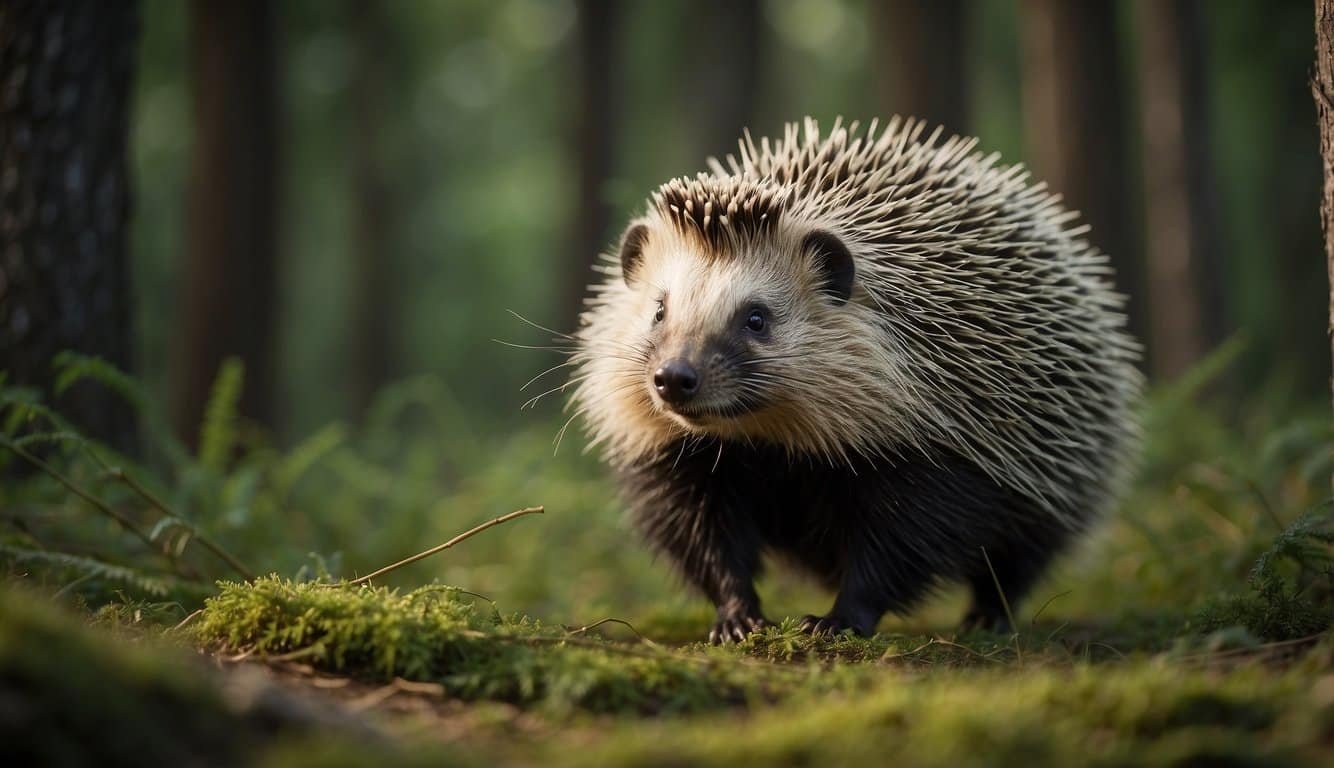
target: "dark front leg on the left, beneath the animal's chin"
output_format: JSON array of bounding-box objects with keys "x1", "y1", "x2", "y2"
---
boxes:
[{"x1": 636, "y1": 480, "x2": 768, "y2": 644}]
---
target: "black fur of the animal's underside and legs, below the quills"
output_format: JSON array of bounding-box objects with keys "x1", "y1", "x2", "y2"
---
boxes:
[{"x1": 622, "y1": 439, "x2": 1075, "y2": 641}]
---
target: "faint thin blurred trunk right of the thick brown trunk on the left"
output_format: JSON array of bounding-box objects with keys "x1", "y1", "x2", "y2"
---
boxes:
[{"x1": 348, "y1": 0, "x2": 394, "y2": 416}]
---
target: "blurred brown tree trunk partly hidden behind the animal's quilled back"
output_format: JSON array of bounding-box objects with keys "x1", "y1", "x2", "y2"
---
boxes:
[{"x1": 1021, "y1": 0, "x2": 1147, "y2": 339}]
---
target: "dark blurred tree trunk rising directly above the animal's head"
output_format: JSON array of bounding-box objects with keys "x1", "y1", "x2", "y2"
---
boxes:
[{"x1": 687, "y1": 0, "x2": 766, "y2": 161}]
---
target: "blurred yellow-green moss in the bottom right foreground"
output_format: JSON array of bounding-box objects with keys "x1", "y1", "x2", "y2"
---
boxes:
[{"x1": 252, "y1": 660, "x2": 1334, "y2": 768}]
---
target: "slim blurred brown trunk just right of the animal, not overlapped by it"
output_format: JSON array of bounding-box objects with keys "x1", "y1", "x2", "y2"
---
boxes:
[{"x1": 1135, "y1": 0, "x2": 1226, "y2": 379}]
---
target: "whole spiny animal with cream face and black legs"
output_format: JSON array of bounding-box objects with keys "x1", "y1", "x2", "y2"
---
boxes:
[{"x1": 571, "y1": 117, "x2": 1141, "y2": 643}]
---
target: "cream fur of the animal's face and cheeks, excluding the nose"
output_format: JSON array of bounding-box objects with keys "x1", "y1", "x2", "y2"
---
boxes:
[{"x1": 574, "y1": 215, "x2": 920, "y2": 463}]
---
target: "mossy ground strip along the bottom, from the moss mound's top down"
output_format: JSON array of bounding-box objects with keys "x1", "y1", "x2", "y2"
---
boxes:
[{"x1": 0, "y1": 580, "x2": 1334, "y2": 765}]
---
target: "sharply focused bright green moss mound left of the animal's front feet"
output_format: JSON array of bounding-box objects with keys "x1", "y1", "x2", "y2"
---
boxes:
[{"x1": 193, "y1": 576, "x2": 838, "y2": 712}]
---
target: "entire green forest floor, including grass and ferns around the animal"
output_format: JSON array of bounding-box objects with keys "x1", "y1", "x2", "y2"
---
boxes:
[{"x1": 0, "y1": 362, "x2": 1334, "y2": 768}]
